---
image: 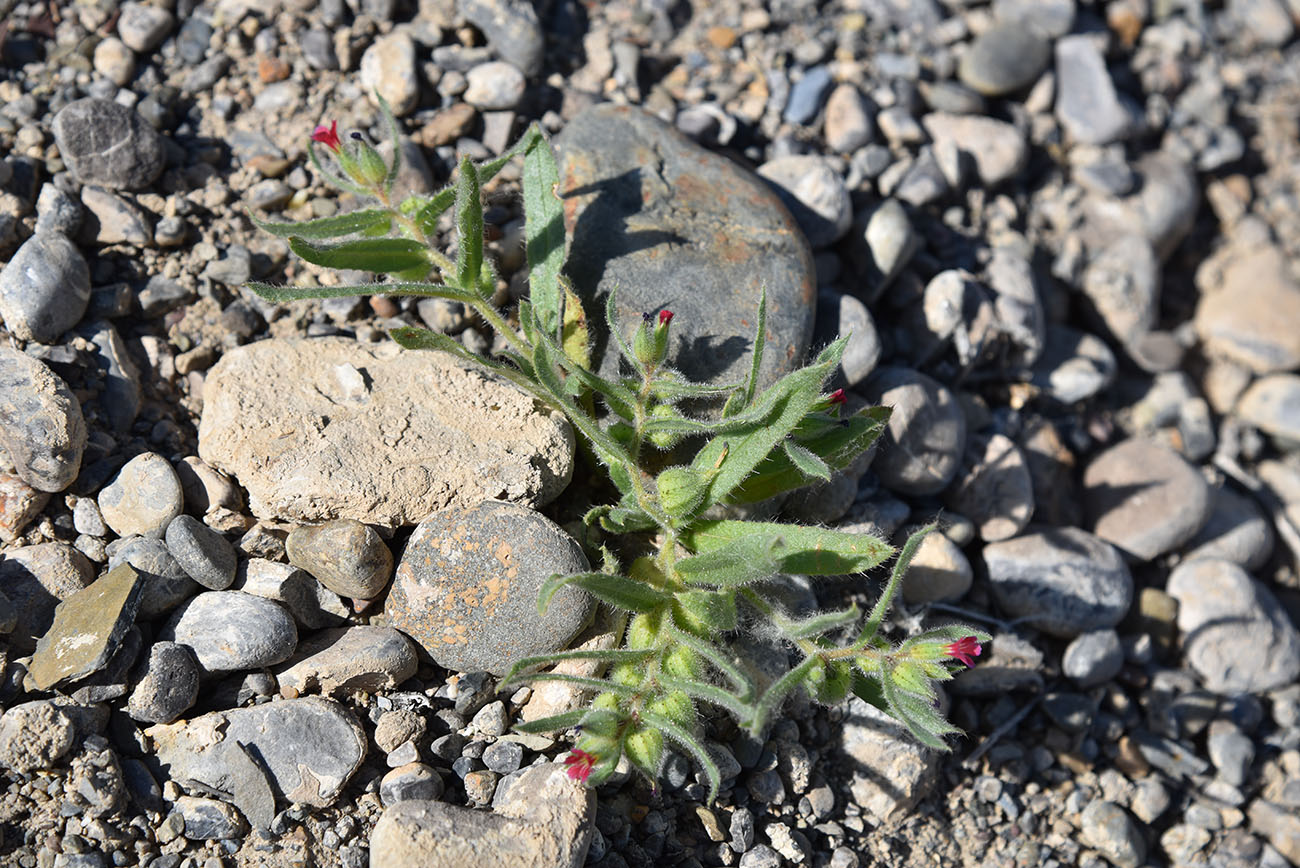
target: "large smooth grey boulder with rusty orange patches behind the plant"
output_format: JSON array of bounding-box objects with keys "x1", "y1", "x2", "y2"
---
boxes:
[{"x1": 555, "y1": 104, "x2": 816, "y2": 385}]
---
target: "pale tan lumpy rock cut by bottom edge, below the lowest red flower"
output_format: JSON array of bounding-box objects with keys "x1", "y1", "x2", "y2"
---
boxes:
[{"x1": 371, "y1": 763, "x2": 595, "y2": 868}]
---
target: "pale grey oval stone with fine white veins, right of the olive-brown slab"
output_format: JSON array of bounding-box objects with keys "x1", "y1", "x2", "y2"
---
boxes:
[{"x1": 159, "y1": 591, "x2": 298, "y2": 673}]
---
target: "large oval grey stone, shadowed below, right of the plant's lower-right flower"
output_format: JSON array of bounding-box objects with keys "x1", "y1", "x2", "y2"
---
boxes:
[{"x1": 984, "y1": 528, "x2": 1134, "y2": 638}]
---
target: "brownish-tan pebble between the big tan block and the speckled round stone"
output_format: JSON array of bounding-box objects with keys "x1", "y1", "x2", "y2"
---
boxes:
[{"x1": 285, "y1": 518, "x2": 393, "y2": 600}]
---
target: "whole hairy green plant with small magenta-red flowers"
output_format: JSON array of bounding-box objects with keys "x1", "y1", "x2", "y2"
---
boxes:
[{"x1": 250, "y1": 100, "x2": 989, "y2": 800}]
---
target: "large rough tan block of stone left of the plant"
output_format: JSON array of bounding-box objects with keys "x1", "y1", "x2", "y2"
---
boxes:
[{"x1": 199, "y1": 337, "x2": 574, "y2": 528}]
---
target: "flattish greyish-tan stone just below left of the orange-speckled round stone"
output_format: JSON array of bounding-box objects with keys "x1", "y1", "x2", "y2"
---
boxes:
[{"x1": 276, "y1": 625, "x2": 417, "y2": 696}]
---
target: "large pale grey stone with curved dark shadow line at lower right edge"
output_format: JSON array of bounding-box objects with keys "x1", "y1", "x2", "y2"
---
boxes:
[{"x1": 1166, "y1": 559, "x2": 1300, "y2": 693}]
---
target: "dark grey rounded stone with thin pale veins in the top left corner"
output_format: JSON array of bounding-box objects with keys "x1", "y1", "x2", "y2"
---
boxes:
[{"x1": 53, "y1": 97, "x2": 166, "y2": 190}]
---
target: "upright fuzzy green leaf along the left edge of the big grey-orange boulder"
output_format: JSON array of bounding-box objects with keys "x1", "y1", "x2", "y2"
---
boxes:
[{"x1": 524, "y1": 125, "x2": 568, "y2": 335}]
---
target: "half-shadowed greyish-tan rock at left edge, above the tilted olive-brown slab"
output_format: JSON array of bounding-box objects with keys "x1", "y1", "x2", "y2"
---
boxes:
[{"x1": 0, "y1": 542, "x2": 95, "y2": 651}]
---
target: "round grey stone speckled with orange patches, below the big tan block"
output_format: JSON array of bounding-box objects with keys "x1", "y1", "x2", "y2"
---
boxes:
[{"x1": 384, "y1": 500, "x2": 593, "y2": 676}]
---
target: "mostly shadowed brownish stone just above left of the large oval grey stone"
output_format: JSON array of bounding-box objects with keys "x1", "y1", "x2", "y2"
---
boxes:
[{"x1": 946, "y1": 434, "x2": 1034, "y2": 542}]
